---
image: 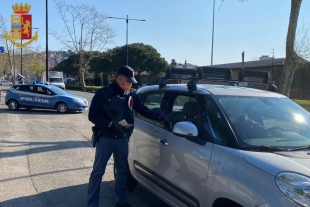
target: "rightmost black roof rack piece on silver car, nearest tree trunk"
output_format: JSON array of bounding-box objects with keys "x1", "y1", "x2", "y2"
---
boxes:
[{"x1": 238, "y1": 70, "x2": 270, "y2": 84}]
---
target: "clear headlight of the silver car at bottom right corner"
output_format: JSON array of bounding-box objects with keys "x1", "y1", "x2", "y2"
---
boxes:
[{"x1": 275, "y1": 172, "x2": 310, "y2": 207}]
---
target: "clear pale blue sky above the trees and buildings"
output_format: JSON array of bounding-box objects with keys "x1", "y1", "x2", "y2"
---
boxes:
[{"x1": 0, "y1": 0, "x2": 310, "y2": 66}]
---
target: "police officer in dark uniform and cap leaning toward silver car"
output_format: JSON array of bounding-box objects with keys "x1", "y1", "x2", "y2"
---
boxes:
[{"x1": 87, "y1": 65, "x2": 167, "y2": 207}]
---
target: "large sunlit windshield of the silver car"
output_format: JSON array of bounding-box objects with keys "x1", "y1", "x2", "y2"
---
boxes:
[{"x1": 215, "y1": 96, "x2": 310, "y2": 149}]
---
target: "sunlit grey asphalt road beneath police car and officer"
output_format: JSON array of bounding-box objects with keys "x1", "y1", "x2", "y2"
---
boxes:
[{"x1": 0, "y1": 87, "x2": 163, "y2": 207}]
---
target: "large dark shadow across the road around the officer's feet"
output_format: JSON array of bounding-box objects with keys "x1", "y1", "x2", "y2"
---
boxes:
[{"x1": 1, "y1": 181, "x2": 167, "y2": 207}]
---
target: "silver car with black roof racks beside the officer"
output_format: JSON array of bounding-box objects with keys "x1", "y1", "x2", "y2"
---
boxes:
[{"x1": 124, "y1": 69, "x2": 310, "y2": 207}]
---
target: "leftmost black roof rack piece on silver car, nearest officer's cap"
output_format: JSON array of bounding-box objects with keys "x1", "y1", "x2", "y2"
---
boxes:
[{"x1": 159, "y1": 68, "x2": 197, "y2": 88}]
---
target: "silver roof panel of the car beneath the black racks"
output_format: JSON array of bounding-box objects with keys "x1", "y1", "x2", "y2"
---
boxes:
[{"x1": 138, "y1": 84, "x2": 287, "y2": 98}]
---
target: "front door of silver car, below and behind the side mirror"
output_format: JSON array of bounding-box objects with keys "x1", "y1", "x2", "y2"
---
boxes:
[{"x1": 155, "y1": 93, "x2": 213, "y2": 206}]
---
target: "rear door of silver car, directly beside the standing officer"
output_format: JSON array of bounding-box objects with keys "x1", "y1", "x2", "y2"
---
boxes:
[{"x1": 128, "y1": 91, "x2": 164, "y2": 192}]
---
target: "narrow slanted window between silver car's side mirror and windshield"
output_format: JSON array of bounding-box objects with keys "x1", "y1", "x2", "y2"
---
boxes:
[{"x1": 201, "y1": 97, "x2": 235, "y2": 146}]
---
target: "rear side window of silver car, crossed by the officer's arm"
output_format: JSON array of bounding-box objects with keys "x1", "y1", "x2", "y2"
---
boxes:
[{"x1": 134, "y1": 91, "x2": 165, "y2": 127}]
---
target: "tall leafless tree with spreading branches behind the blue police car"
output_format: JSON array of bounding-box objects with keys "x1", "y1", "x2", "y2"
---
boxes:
[{"x1": 51, "y1": 0, "x2": 115, "y2": 90}]
